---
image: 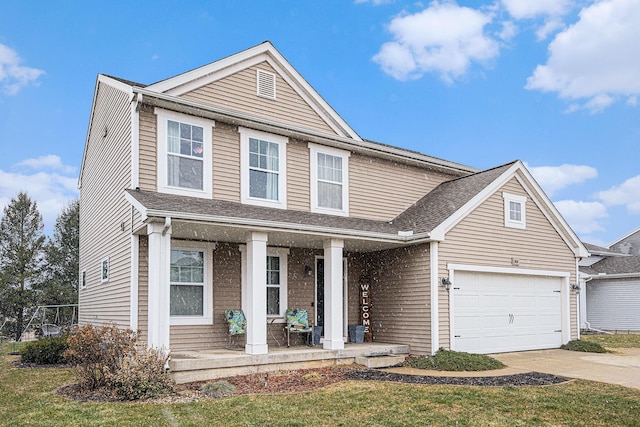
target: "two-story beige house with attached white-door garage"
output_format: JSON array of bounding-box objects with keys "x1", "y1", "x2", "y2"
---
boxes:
[{"x1": 79, "y1": 42, "x2": 588, "y2": 354}]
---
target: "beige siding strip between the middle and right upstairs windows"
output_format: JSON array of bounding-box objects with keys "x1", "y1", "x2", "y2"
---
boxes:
[{"x1": 287, "y1": 139, "x2": 311, "y2": 212}]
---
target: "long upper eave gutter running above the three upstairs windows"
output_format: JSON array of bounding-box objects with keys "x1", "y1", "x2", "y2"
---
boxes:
[{"x1": 133, "y1": 87, "x2": 480, "y2": 175}]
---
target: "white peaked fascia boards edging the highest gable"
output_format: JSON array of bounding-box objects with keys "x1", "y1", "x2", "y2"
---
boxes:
[{"x1": 146, "y1": 42, "x2": 362, "y2": 141}]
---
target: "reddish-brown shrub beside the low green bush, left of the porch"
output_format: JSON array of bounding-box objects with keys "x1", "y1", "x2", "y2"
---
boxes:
[{"x1": 64, "y1": 325, "x2": 137, "y2": 390}]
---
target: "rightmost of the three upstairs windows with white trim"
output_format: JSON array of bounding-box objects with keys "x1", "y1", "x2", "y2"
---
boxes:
[{"x1": 309, "y1": 143, "x2": 350, "y2": 216}]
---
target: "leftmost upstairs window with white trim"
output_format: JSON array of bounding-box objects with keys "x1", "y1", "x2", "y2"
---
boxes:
[{"x1": 155, "y1": 109, "x2": 214, "y2": 198}]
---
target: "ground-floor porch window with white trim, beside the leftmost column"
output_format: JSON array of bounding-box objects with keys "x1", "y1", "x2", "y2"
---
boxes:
[{"x1": 169, "y1": 245, "x2": 212, "y2": 325}]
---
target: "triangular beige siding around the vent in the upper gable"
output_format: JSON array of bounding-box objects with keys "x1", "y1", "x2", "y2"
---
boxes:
[{"x1": 182, "y1": 62, "x2": 335, "y2": 135}]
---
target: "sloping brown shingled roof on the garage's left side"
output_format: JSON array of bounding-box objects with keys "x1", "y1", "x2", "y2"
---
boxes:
[{"x1": 392, "y1": 162, "x2": 516, "y2": 233}]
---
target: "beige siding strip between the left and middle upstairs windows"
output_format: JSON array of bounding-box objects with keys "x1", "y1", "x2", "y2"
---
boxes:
[{"x1": 213, "y1": 122, "x2": 240, "y2": 203}]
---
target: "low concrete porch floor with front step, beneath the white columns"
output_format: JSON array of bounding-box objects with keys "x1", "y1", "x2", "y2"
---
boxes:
[{"x1": 169, "y1": 342, "x2": 410, "y2": 384}]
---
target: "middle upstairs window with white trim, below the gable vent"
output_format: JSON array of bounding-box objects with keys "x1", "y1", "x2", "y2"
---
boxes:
[{"x1": 238, "y1": 127, "x2": 288, "y2": 209}]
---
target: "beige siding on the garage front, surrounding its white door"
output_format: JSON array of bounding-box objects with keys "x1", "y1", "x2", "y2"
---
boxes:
[{"x1": 438, "y1": 179, "x2": 577, "y2": 347}]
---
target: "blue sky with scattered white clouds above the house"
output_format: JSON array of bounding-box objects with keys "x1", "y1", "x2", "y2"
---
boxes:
[{"x1": 0, "y1": 0, "x2": 640, "y2": 245}]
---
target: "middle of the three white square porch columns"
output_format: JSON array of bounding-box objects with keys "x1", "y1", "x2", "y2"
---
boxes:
[{"x1": 245, "y1": 232, "x2": 269, "y2": 354}]
